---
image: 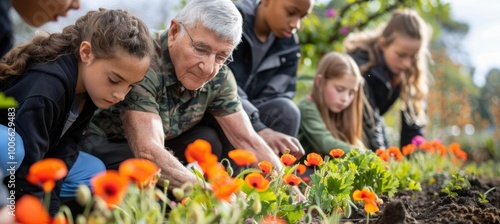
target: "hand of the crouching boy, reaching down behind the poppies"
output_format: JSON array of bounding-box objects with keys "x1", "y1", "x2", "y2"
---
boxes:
[{"x1": 258, "y1": 128, "x2": 305, "y2": 159}]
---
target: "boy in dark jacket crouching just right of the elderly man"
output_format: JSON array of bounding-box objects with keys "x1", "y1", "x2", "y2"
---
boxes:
[{"x1": 229, "y1": 0, "x2": 314, "y2": 158}]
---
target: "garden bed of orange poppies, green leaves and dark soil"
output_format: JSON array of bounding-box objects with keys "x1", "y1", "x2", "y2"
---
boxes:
[{"x1": 16, "y1": 140, "x2": 500, "y2": 224}]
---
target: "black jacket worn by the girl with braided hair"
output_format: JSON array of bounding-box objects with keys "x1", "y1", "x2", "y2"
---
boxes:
[{"x1": 0, "y1": 56, "x2": 96, "y2": 214}]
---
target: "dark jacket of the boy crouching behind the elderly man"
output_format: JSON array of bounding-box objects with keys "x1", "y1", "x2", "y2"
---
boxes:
[{"x1": 229, "y1": 0, "x2": 300, "y2": 131}]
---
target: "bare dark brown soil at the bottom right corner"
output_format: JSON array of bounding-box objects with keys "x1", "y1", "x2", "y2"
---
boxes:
[{"x1": 343, "y1": 177, "x2": 500, "y2": 224}]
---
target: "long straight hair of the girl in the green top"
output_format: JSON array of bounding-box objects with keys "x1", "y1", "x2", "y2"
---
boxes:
[{"x1": 311, "y1": 52, "x2": 365, "y2": 148}]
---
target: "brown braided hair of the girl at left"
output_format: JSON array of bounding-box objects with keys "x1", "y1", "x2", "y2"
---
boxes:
[{"x1": 0, "y1": 9, "x2": 153, "y2": 79}]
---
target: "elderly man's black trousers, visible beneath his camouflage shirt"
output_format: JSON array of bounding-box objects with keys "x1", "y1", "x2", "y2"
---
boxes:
[{"x1": 80, "y1": 113, "x2": 234, "y2": 170}]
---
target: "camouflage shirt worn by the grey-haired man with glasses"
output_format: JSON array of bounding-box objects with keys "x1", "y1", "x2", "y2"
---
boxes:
[{"x1": 87, "y1": 30, "x2": 242, "y2": 141}]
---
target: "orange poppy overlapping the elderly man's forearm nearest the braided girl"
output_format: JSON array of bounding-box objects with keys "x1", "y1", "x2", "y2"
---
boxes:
[{"x1": 118, "y1": 158, "x2": 160, "y2": 188}]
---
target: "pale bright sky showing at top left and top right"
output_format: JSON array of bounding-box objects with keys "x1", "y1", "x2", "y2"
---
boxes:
[{"x1": 37, "y1": 0, "x2": 500, "y2": 86}]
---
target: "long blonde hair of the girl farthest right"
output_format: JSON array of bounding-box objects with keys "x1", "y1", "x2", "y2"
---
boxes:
[{"x1": 344, "y1": 9, "x2": 430, "y2": 127}]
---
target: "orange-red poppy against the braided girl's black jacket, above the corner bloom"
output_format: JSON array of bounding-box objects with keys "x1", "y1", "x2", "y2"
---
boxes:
[{"x1": 26, "y1": 158, "x2": 68, "y2": 192}]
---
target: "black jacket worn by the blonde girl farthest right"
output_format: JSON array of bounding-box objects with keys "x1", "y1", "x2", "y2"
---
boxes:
[{"x1": 350, "y1": 50, "x2": 423, "y2": 150}]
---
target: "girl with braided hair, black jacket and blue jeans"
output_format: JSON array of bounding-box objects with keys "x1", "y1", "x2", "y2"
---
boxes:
[{"x1": 0, "y1": 9, "x2": 154, "y2": 215}]
